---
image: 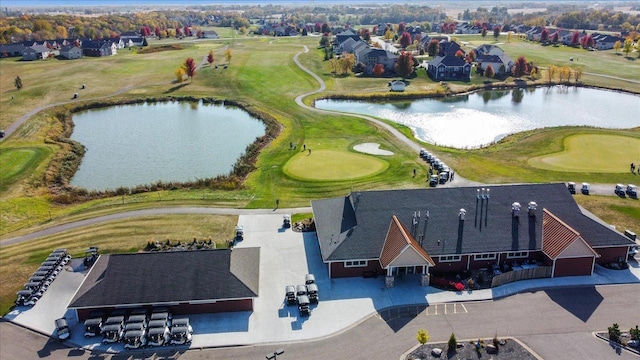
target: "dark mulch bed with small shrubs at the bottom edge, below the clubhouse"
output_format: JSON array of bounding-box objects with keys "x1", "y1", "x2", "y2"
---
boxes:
[{"x1": 405, "y1": 339, "x2": 536, "y2": 360}]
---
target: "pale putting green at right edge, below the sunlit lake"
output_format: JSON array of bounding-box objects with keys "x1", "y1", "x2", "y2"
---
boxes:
[{"x1": 529, "y1": 134, "x2": 640, "y2": 173}]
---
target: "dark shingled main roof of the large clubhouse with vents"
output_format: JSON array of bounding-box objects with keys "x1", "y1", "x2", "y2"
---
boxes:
[{"x1": 311, "y1": 183, "x2": 632, "y2": 261}]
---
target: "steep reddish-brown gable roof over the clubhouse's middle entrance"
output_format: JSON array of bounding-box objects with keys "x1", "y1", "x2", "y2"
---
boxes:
[{"x1": 380, "y1": 215, "x2": 435, "y2": 269}]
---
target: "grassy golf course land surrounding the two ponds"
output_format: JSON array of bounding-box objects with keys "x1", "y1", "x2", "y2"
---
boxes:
[{"x1": 0, "y1": 28, "x2": 640, "y2": 313}]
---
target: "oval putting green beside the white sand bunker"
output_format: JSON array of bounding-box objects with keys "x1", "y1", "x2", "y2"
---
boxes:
[{"x1": 283, "y1": 150, "x2": 389, "y2": 180}]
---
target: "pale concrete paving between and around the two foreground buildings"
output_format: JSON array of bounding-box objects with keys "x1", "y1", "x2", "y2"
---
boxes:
[{"x1": 6, "y1": 212, "x2": 640, "y2": 352}]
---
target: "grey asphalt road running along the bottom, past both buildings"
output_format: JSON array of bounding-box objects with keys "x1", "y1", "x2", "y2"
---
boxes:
[{"x1": 0, "y1": 284, "x2": 640, "y2": 360}]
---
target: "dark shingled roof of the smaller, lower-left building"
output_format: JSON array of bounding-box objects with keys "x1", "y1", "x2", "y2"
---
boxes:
[{"x1": 69, "y1": 248, "x2": 260, "y2": 308}]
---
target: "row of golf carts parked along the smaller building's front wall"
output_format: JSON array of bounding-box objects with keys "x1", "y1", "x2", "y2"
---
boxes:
[{"x1": 84, "y1": 307, "x2": 193, "y2": 349}]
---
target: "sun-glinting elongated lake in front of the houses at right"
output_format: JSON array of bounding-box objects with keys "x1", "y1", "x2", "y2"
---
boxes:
[{"x1": 316, "y1": 86, "x2": 640, "y2": 149}]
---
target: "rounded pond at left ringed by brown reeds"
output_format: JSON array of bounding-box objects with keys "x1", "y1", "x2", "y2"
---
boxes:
[{"x1": 71, "y1": 102, "x2": 266, "y2": 190}]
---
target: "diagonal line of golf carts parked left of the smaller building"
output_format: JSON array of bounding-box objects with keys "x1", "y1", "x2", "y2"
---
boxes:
[{"x1": 16, "y1": 249, "x2": 71, "y2": 306}]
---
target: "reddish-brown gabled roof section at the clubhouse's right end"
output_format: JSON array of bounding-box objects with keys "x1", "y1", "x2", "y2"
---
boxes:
[{"x1": 542, "y1": 209, "x2": 599, "y2": 260}]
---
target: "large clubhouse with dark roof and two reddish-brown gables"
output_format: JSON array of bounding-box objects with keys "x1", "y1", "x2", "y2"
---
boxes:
[{"x1": 311, "y1": 183, "x2": 635, "y2": 278}]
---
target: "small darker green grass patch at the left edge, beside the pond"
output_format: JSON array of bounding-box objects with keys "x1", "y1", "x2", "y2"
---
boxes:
[{"x1": 0, "y1": 147, "x2": 49, "y2": 191}]
